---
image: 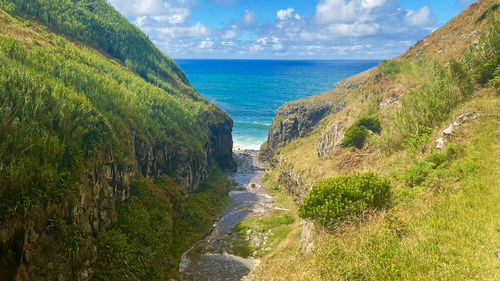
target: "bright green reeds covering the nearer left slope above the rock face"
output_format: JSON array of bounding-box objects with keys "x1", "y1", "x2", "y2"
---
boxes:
[{"x1": 0, "y1": 1, "x2": 228, "y2": 221}]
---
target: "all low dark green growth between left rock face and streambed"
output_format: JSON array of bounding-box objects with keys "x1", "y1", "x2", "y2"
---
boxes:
[{"x1": 94, "y1": 167, "x2": 230, "y2": 281}]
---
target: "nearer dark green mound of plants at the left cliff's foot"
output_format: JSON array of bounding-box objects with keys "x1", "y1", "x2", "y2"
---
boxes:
[{"x1": 94, "y1": 179, "x2": 177, "y2": 280}]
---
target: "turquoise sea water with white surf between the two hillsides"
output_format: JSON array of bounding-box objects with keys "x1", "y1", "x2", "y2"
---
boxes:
[{"x1": 176, "y1": 59, "x2": 378, "y2": 149}]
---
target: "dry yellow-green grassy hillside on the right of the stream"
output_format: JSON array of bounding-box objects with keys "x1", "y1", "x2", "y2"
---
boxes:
[{"x1": 252, "y1": 0, "x2": 500, "y2": 280}]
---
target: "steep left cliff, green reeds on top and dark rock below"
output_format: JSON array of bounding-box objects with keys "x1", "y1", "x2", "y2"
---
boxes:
[{"x1": 0, "y1": 0, "x2": 235, "y2": 280}]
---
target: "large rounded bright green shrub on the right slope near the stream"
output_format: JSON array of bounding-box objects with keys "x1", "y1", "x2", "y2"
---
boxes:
[{"x1": 300, "y1": 173, "x2": 391, "y2": 225}]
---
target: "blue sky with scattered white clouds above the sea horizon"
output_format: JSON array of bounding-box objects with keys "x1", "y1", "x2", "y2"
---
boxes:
[{"x1": 108, "y1": 0, "x2": 474, "y2": 59}]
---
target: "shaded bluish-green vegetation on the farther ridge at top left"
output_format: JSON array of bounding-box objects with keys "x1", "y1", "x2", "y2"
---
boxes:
[{"x1": 0, "y1": 0, "x2": 193, "y2": 93}]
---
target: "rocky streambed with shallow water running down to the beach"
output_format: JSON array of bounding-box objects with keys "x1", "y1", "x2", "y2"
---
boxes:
[{"x1": 179, "y1": 150, "x2": 275, "y2": 281}]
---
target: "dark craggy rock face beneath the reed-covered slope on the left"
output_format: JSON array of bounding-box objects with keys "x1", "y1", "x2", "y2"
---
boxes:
[{"x1": 0, "y1": 115, "x2": 235, "y2": 281}]
